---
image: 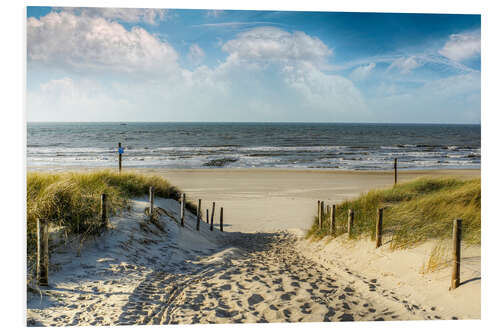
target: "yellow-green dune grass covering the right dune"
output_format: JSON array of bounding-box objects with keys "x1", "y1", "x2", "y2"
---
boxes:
[{"x1": 307, "y1": 178, "x2": 481, "y2": 249}]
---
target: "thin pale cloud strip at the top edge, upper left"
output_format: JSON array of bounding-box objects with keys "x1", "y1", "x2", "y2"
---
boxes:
[{"x1": 57, "y1": 7, "x2": 167, "y2": 25}]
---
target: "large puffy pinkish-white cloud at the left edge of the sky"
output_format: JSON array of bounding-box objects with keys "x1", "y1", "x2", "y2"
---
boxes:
[{"x1": 26, "y1": 12, "x2": 178, "y2": 73}]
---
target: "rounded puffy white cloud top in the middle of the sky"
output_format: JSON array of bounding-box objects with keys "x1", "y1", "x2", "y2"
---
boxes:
[{"x1": 222, "y1": 27, "x2": 333, "y2": 66}]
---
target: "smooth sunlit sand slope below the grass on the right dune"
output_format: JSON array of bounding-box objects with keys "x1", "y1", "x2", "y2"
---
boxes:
[{"x1": 297, "y1": 235, "x2": 481, "y2": 319}]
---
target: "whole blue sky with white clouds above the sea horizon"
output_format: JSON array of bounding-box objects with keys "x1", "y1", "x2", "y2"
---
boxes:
[{"x1": 26, "y1": 7, "x2": 481, "y2": 123}]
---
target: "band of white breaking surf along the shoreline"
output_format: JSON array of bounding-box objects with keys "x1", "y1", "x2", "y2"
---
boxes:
[{"x1": 27, "y1": 145, "x2": 481, "y2": 170}]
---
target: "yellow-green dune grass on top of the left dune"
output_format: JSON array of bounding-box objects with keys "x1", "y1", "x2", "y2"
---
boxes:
[{"x1": 27, "y1": 170, "x2": 196, "y2": 264}]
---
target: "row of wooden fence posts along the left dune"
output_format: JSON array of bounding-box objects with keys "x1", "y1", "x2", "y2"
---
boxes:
[{"x1": 36, "y1": 186, "x2": 224, "y2": 286}]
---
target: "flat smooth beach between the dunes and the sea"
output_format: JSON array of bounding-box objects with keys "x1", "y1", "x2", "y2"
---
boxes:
[{"x1": 139, "y1": 169, "x2": 480, "y2": 232}]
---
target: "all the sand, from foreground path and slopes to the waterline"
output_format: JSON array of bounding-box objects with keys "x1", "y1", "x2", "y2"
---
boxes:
[{"x1": 27, "y1": 169, "x2": 481, "y2": 326}]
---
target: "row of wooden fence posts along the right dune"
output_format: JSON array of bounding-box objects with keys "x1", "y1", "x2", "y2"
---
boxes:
[{"x1": 318, "y1": 200, "x2": 462, "y2": 289}]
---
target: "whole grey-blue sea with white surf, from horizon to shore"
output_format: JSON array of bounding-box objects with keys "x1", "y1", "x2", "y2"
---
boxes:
[{"x1": 27, "y1": 122, "x2": 481, "y2": 170}]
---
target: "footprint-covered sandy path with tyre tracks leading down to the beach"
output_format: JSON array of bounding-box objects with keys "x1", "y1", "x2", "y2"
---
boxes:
[{"x1": 124, "y1": 233, "x2": 439, "y2": 324}]
